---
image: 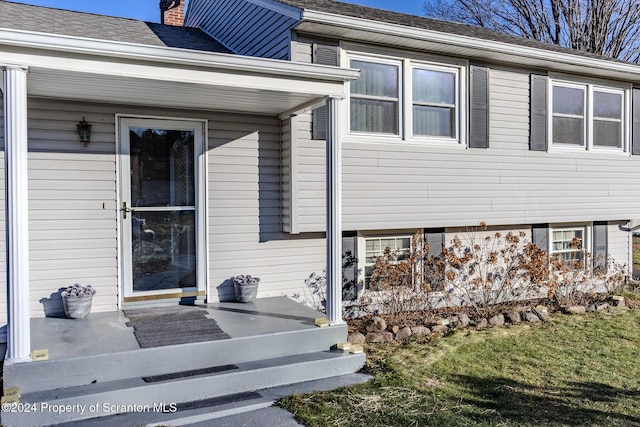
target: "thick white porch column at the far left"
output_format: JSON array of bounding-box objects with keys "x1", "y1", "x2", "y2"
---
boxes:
[{"x1": 2, "y1": 66, "x2": 31, "y2": 364}]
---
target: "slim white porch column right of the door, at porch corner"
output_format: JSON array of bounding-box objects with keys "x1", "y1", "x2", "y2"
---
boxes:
[{"x1": 327, "y1": 98, "x2": 344, "y2": 325}]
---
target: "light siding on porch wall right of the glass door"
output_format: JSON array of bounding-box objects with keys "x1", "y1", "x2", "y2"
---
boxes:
[{"x1": 208, "y1": 114, "x2": 325, "y2": 301}]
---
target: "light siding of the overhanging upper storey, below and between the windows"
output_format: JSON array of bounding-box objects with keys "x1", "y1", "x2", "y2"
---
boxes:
[{"x1": 292, "y1": 67, "x2": 640, "y2": 236}]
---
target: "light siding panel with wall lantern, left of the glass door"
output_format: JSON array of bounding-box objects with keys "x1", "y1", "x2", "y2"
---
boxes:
[{"x1": 28, "y1": 98, "x2": 118, "y2": 317}]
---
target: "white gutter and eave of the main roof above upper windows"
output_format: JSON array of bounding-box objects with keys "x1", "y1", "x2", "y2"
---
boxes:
[{"x1": 295, "y1": 10, "x2": 640, "y2": 82}]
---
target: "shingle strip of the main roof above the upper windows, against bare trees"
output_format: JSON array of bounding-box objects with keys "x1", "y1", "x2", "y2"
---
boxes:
[{"x1": 276, "y1": 0, "x2": 624, "y2": 62}]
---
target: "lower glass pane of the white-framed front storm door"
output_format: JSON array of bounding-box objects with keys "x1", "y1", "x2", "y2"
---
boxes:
[{"x1": 131, "y1": 211, "x2": 196, "y2": 291}]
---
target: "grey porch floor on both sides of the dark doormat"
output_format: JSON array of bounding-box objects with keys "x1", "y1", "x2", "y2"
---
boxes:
[{"x1": 26, "y1": 297, "x2": 324, "y2": 360}]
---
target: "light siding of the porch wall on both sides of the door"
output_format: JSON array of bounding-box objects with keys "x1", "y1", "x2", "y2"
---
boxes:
[{"x1": 0, "y1": 98, "x2": 332, "y2": 322}]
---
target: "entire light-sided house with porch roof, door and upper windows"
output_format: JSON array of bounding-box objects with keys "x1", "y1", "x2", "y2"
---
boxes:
[{"x1": 0, "y1": 0, "x2": 640, "y2": 363}]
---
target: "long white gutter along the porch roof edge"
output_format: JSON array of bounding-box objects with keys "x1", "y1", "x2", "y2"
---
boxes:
[{"x1": 0, "y1": 28, "x2": 359, "y2": 82}]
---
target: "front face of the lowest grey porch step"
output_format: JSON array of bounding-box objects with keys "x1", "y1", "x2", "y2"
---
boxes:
[{"x1": 2, "y1": 351, "x2": 365, "y2": 426}]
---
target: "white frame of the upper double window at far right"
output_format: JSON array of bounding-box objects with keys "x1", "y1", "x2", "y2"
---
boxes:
[{"x1": 547, "y1": 76, "x2": 631, "y2": 155}]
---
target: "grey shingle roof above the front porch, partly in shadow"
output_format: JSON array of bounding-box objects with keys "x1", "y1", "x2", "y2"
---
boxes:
[{"x1": 0, "y1": 0, "x2": 231, "y2": 53}]
